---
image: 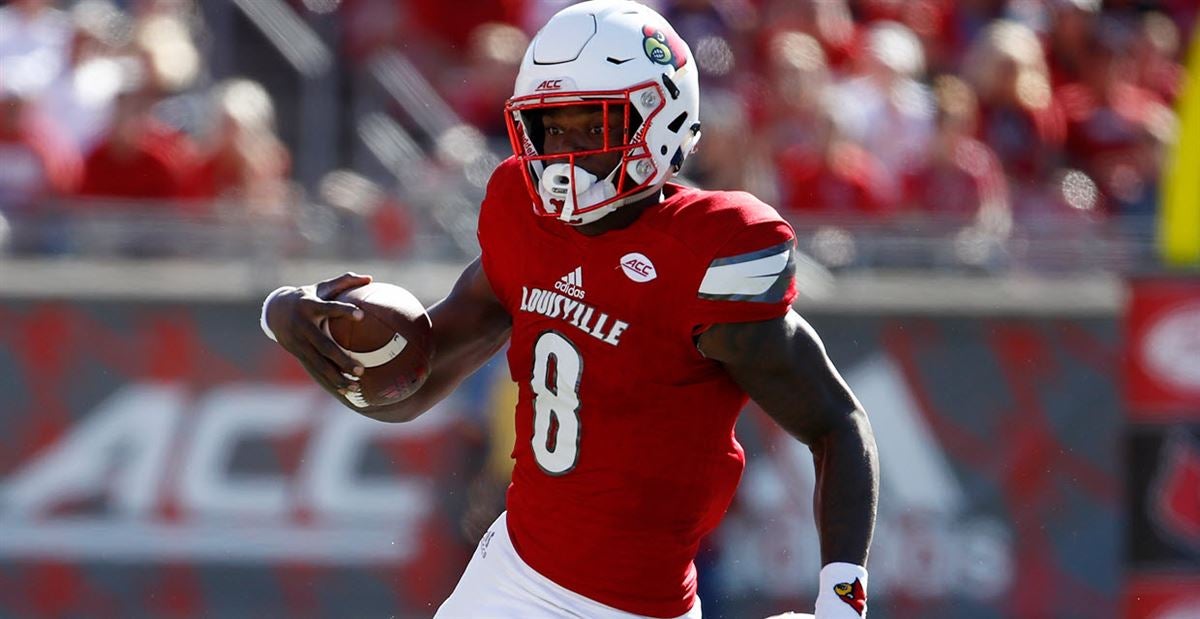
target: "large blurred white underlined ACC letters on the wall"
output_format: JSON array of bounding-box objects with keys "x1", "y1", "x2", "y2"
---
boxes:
[{"x1": 0, "y1": 383, "x2": 449, "y2": 564}]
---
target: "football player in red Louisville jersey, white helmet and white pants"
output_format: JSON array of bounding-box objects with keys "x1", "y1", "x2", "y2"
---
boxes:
[{"x1": 263, "y1": 0, "x2": 878, "y2": 619}]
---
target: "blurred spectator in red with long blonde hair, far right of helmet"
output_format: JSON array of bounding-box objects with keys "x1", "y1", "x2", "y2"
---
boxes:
[{"x1": 964, "y1": 20, "x2": 1066, "y2": 185}]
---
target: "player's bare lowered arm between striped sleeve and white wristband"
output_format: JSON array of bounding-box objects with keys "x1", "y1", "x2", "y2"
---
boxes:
[{"x1": 697, "y1": 310, "x2": 880, "y2": 617}]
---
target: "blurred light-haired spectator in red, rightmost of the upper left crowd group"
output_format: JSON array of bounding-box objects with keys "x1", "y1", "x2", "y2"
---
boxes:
[{"x1": 188, "y1": 79, "x2": 290, "y2": 214}]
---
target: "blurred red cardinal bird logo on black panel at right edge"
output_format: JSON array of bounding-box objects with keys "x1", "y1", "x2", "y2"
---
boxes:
[{"x1": 1151, "y1": 432, "x2": 1200, "y2": 547}]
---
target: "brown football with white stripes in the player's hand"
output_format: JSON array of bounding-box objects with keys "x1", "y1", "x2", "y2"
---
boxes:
[{"x1": 324, "y1": 282, "x2": 433, "y2": 409}]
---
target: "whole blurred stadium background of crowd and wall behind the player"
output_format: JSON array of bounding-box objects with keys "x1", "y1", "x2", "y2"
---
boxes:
[{"x1": 0, "y1": 0, "x2": 1200, "y2": 619}]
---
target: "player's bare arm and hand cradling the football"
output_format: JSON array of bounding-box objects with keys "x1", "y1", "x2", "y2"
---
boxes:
[{"x1": 263, "y1": 258, "x2": 512, "y2": 421}]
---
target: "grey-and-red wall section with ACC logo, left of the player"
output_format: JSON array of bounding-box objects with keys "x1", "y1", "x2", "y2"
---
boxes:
[{"x1": 0, "y1": 301, "x2": 479, "y2": 617}]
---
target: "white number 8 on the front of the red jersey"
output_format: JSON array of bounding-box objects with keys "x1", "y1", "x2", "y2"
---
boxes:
[{"x1": 530, "y1": 331, "x2": 583, "y2": 475}]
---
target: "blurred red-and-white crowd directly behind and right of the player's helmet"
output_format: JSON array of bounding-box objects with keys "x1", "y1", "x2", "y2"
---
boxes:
[{"x1": 342, "y1": 0, "x2": 1198, "y2": 247}]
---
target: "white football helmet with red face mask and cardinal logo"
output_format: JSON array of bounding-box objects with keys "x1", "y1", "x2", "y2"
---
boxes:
[{"x1": 505, "y1": 0, "x2": 700, "y2": 226}]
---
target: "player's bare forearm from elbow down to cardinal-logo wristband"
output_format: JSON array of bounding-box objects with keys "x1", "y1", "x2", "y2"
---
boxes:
[{"x1": 809, "y1": 410, "x2": 880, "y2": 565}]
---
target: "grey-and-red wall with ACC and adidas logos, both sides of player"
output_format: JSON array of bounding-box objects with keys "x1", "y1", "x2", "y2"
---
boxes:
[{"x1": 0, "y1": 304, "x2": 1120, "y2": 619}]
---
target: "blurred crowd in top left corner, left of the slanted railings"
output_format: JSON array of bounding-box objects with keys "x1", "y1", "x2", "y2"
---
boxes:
[{"x1": 0, "y1": 0, "x2": 289, "y2": 215}]
